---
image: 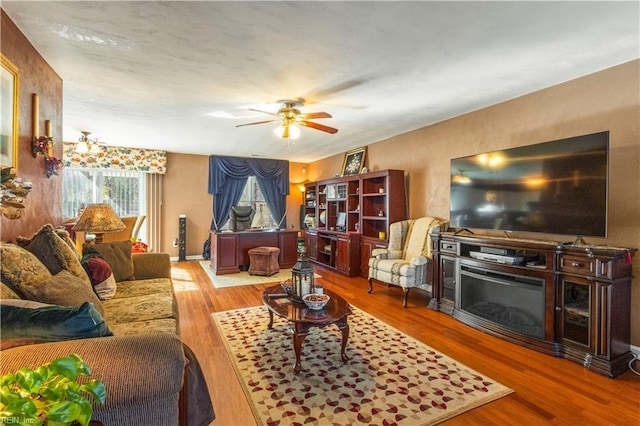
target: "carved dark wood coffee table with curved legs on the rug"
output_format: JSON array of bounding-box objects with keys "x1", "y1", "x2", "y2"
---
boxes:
[{"x1": 262, "y1": 284, "x2": 351, "y2": 374}]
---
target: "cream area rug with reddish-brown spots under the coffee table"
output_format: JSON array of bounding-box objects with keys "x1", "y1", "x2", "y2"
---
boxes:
[{"x1": 213, "y1": 306, "x2": 513, "y2": 426}]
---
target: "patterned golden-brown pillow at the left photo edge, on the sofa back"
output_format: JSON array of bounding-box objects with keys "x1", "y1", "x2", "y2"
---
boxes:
[{"x1": 0, "y1": 242, "x2": 51, "y2": 296}]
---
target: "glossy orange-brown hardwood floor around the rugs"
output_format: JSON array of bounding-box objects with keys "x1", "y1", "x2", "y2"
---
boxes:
[{"x1": 172, "y1": 261, "x2": 640, "y2": 426}]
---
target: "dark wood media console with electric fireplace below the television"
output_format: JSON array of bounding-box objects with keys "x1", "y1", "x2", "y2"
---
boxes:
[{"x1": 429, "y1": 232, "x2": 636, "y2": 377}]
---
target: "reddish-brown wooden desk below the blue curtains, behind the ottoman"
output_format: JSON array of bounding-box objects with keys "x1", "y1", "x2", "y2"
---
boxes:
[{"x1": 211, "y1": 230, "x2": 298, "y2": 275}]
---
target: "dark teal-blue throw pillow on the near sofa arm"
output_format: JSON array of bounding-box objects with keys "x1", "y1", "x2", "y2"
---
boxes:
[{"x1": 0, "y1": 302, "x2": 113, "y2": 342}]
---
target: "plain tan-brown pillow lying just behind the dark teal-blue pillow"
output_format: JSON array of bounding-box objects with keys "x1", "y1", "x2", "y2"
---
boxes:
[{"x1": 14, "y1": 271, "x2": 104, "y2": 315}]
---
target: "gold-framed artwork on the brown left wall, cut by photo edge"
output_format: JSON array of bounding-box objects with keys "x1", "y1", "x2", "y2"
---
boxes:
[{"x1": 0, "y1": 53, "x2": 18, "y2": 167}]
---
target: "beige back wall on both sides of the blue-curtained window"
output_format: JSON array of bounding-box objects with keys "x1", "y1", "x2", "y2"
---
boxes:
[{"x1": 159, "y1": 153, "x2": 306, "y2": 257}]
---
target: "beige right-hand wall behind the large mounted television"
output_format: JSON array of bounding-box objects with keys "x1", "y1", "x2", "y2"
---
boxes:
[{"x1": 309, "y1": 60, "x2": 640, "y2": 346}]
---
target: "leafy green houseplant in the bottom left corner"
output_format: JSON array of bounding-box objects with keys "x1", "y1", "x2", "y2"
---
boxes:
[{"x1": 0, "y1": 354, "x2": 107, "y2": 426}]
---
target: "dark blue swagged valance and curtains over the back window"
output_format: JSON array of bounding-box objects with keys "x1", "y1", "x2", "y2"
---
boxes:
[{"x1": 209, "y1": 155, "x2": 289, "y2": 231}]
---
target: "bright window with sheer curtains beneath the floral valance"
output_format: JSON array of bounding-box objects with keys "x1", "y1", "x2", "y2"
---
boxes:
[{"x1": 62, "y1": 168, "x2": 146, "y2": 223}]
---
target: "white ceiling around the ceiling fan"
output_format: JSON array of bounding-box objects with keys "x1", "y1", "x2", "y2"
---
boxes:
[{"x1": 2, "y1": 0, "x2": 640, "y2": 162}]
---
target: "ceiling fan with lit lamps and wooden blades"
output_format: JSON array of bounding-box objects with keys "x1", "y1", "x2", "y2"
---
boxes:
[{"x1": 236, "y1": 99, "x2": 338, "y2": 139}]
